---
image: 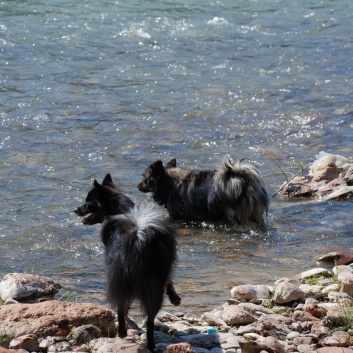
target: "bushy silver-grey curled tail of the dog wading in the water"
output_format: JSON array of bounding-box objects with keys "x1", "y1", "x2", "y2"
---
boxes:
[{"x1": 214, "y1": 157, "x2": 269, "y2": 224}]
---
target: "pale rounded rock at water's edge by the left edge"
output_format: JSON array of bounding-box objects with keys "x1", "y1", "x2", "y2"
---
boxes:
[{"x1": 0, "y1": 273, "x2": 61, "y2": 302}]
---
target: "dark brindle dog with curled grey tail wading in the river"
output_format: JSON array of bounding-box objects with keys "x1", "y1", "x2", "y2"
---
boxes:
[{"x1": 138, "y1": 157, "x2": 269, "y2": 226}]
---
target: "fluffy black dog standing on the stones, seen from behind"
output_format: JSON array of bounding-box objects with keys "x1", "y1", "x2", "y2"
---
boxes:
[{"x1": 75, "y1": 174, "x2": 180, "y2": 350}]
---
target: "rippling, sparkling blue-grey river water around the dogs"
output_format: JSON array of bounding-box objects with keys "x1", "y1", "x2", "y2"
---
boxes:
[{"x1": 0, "y1": 0, "x2": 353, "y2": 312}]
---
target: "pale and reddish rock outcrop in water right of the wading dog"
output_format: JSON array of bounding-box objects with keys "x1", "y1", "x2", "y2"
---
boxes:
[{"x1": 277, "y1": 151, "x2": 353, "y2": 200}]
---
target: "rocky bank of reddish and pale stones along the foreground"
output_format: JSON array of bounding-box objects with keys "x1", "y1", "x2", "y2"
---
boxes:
[{"x1": 0, "y1": 254, "x2": 353, "y2": 353}]
